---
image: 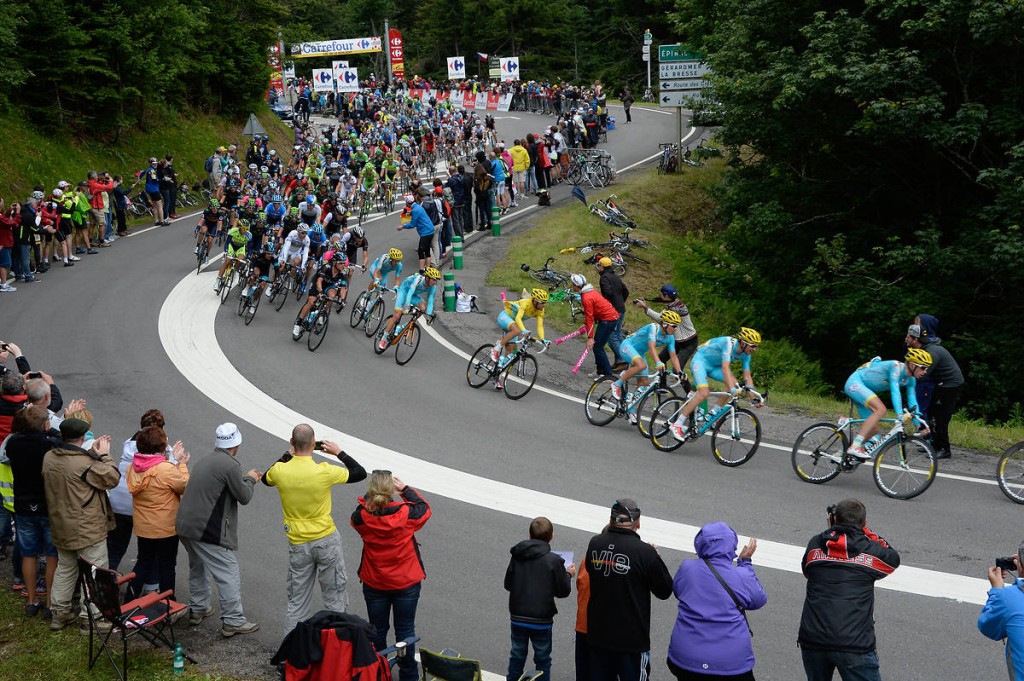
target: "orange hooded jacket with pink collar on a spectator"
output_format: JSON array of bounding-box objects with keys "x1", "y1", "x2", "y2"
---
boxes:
[{"x1": 127, "y1": 454, "x2": 188, "y2": 539}]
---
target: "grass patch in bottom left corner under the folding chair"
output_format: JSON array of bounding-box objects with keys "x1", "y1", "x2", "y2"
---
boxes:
[{"x1": 0, "y1": 585, "x2": 241, "y2": 681}]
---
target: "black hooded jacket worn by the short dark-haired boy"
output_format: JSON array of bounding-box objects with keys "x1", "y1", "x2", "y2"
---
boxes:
[{"x1": 505, "y1": 539, "x2": 572, "y2": 627}]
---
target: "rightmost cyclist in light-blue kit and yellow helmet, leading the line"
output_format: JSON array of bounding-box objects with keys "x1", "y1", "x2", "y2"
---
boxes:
[{"x1": 843, "y1": 347, "x2": 932, "y2": 460}]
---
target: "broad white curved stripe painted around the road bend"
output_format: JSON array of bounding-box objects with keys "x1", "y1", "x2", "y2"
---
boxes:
[{"x1": 159, "y1": 272, "x2": 988, "y2": 605}]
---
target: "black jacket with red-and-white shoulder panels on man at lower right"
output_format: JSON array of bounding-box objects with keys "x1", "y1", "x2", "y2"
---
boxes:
[{"x1": 797, "y1": 525, "x2": 899, "y2": 653}]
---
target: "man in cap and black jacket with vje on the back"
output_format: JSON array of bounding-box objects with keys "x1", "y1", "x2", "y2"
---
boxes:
[{"x1": 586, "y1": 499, "x2": 672, "y2": 681}]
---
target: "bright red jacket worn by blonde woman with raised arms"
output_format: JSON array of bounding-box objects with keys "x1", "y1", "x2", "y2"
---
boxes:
[{"x1": 351, "y1": 486, "x2": 430, "y2": 591}]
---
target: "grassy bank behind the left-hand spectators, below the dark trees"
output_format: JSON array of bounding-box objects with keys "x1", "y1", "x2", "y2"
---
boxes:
[{"x1": 0, "y1": 105, "x2": 294, "y2": 199}]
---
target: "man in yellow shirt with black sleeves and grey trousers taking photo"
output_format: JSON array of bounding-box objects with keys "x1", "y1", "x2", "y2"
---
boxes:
[{"x1": 263, "y1": 423, "x2": 367, "y2": 636}]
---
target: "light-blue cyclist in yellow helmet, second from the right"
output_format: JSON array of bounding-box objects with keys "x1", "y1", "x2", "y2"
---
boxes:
[{"x1": 669, "y1": 327, "x2": 761, "y2": 441}]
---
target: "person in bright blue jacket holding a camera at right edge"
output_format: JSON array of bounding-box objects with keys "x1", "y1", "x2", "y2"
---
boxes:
[{"x1": 978, "y1": 544, "x2": 1024, "y2": 681}]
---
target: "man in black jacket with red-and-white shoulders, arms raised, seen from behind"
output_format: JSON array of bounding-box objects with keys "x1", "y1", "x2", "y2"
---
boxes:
[{"x1": 797, "y1": 499, "x2": 899, "y2": 681}]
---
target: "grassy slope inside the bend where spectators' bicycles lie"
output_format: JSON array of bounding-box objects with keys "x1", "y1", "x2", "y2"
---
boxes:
[{"x1": 486, "y1": 164, "x2": 1024, "y2": 453}]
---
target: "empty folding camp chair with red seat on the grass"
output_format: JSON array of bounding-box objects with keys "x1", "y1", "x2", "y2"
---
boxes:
[{"x1": 78, "y1": 557, "x2": 196, "y2": 681}]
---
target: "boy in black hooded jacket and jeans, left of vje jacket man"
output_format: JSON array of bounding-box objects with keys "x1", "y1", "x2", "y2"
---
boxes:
[{"x1": 505, "y1": 517, "x2": 575, "y2": 681}]
